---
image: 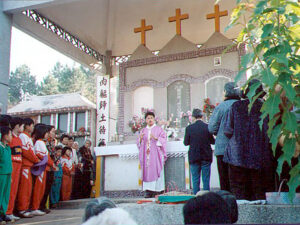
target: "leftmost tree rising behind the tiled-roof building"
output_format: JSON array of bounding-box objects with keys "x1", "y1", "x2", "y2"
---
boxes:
[{"x1": 8, "y1": 65, "x2": 39, "y2": 105}]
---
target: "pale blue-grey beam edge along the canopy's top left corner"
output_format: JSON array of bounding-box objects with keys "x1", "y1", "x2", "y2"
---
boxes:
[{"x1": 3, "y1": 0, "x2": 84, "y2": 13}]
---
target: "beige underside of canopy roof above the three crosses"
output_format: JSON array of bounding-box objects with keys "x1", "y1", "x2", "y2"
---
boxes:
[{"x1": 3, "y1": 0, "x2": 239, "y2": 64}]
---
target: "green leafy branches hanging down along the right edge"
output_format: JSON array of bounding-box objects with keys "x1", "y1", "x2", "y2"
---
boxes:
[{"x1": 226, "y1": 0, "x2": 300, "y2": 201}]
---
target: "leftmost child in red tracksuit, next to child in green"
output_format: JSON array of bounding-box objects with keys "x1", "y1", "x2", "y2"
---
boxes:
[{"x1": 6, "y1": 117, "x2": 24, "y2": 220}]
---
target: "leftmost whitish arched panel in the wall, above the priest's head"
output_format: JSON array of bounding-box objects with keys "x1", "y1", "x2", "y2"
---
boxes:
[{"x1": 133, "y1": 86, "x2": 154, "y2": 116}]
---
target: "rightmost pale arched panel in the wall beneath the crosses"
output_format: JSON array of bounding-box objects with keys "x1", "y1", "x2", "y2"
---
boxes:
[{"x1": 205, "y1": 76, "x2": 230, "y2": 105}]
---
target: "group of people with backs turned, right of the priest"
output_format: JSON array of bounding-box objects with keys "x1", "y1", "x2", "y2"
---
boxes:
[{"x1": 184, "y1": 79, "x2": 299, "y2": 201}]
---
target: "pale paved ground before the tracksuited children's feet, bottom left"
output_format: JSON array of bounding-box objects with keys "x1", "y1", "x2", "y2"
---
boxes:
[{"x1": 14, "y1": 209, "x2": 84, "y2": 225}]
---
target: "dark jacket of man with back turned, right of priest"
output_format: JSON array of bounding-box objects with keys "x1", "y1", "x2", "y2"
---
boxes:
[{"x1": 183, "y1": 120, "x2": 215, "y2": 164}]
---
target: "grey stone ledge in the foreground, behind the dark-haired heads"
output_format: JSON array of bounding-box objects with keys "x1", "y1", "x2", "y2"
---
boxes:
[{"x1": 59, "y1": 198, "x2": 300, "y2": 225}]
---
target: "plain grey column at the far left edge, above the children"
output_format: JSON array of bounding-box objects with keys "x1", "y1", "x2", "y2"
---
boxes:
[{"x1": 0, "y1": 4, "x2": 12, "y2": 114}]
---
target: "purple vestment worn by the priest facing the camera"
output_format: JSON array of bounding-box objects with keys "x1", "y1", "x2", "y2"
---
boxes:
[{"x1": 137, "y1": 126, "x2": 167, "y2": 182}]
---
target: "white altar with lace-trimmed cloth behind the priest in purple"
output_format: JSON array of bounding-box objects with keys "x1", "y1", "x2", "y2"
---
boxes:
[{"x1": 95, "y1": 141, "x2": 220, "y2": 193}]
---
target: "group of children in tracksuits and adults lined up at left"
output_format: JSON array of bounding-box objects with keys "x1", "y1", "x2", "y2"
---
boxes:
[{"x1": 0, "y1": 115, "x2": 95, "y2": 224}]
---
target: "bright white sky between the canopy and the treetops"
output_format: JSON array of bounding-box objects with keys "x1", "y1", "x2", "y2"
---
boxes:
[{"x1": 10, "y1": 27, "x2": 78, "y2": 82}]
